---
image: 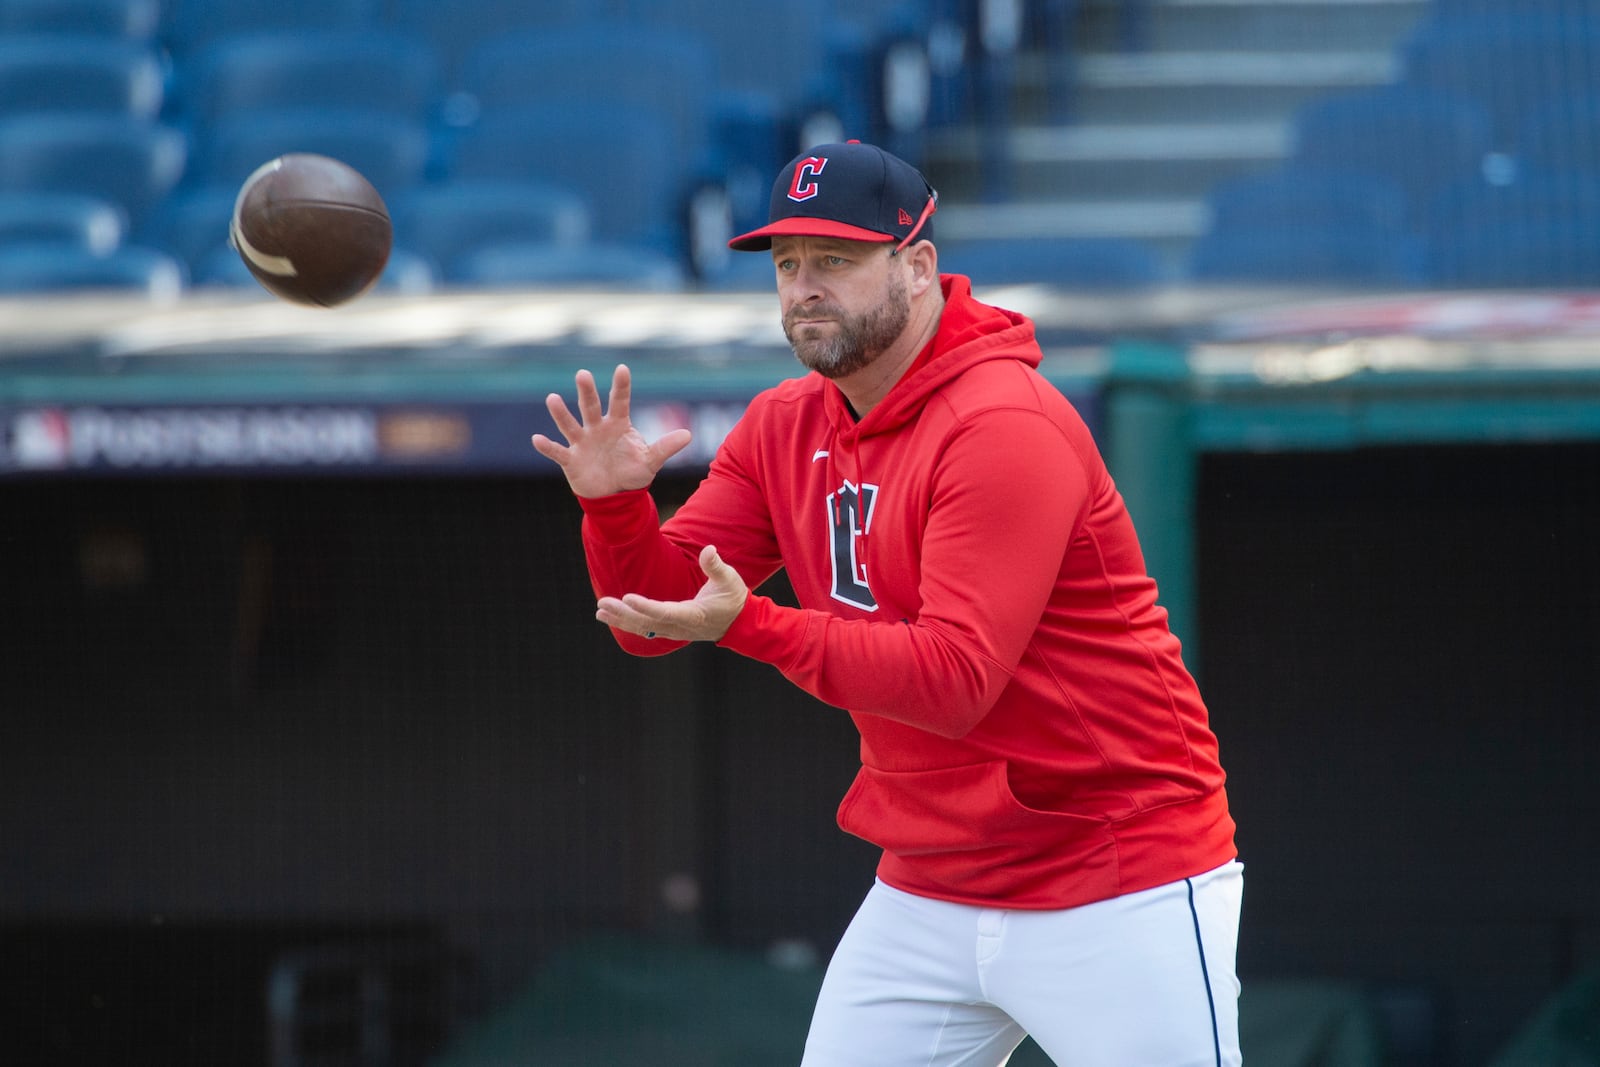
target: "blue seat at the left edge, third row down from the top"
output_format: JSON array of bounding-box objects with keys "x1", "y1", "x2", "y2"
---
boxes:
[{"x1": 0, "y1": 115, "x2": 189, "y2": 227}]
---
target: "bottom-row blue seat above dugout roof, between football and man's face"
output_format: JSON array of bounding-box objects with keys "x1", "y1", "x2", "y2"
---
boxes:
[{"x1": 454, "y1": 242, "x2": 688, "y2": 291}]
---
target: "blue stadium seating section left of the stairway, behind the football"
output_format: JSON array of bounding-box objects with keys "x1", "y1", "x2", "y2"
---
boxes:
[{"x1": 0, "y1": 0, "x2": 960, "y2": 293}]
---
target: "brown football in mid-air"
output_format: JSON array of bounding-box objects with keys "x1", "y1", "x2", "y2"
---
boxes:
[{"x1": 229, "y1": 152, "x2": 394, "y2": 307}]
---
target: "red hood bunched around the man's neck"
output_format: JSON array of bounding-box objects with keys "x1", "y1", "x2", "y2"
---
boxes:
[{"x1": 829, "y1": 274, "x2": 1043, "y2": 437}]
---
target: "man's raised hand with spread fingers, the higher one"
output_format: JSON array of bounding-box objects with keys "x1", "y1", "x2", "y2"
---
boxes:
[{"x1": 533, "y1": 363, "x2": 691, "y2": 502}]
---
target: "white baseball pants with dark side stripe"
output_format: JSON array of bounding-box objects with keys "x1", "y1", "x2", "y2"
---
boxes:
[{"x1": 803, "y1": 862, "x2": 1243, "y2": 1067}]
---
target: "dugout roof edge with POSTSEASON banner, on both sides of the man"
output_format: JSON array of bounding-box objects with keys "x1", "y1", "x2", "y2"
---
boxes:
[{"x1": 9, "y1": 286, "x2": 1600, "y2": 482}]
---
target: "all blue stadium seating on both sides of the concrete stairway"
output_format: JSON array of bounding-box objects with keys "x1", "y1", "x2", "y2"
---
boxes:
[{"x1": 0, "y1": 0, "x2": 1600, "y2": 293}]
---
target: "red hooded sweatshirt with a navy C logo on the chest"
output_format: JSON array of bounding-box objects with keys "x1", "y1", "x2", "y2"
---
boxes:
[{"x1": 582, "y1": 275, "x2": 1235, "y2": 909}]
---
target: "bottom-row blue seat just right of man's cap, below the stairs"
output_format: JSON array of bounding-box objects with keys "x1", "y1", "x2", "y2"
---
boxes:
[{"x1": 936, "y1": 237, "x2": 1163, "y2": 290}]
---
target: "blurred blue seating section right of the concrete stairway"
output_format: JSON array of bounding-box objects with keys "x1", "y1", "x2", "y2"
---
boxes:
[{"x1": 1189, "y1": 0, "x2": 1600, "y2": 288}]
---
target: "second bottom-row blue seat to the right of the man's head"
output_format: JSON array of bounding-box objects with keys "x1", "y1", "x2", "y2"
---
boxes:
[{"x1": 1187, "y1": 227, "x2": 1422, "y2": 288}]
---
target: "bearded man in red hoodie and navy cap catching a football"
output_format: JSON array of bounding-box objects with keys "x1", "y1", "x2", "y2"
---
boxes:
[{"x1": 533, "y1": 142, "x2": 1242, "y2": 1067}]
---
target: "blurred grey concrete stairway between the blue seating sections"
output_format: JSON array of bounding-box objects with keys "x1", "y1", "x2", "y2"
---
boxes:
[{"x1": 928, "y1": 0, "x2": 1429, "y2": 272}]
